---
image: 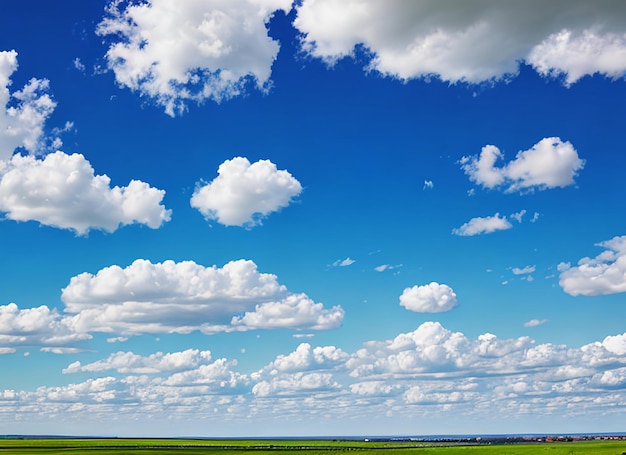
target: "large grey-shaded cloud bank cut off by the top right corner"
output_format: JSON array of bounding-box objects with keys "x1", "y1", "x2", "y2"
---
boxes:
[{"x1": 294, "y1": 0, "x2": 626, "y2": 84}]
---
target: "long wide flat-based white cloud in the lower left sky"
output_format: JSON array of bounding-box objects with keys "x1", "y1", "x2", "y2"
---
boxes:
[{"x1": 61, "y1": 259, "x2": 343, "y2": 335}]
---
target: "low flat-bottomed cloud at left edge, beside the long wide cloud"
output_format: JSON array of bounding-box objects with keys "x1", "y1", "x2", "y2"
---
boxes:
[{"x1": 0, "y1": 303, "x2": 91, "y2": 353}]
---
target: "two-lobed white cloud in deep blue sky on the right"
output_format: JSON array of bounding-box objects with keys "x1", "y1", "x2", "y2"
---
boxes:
[{"x1": 461, "y1": 137, "x2": 585, "y2": 192}]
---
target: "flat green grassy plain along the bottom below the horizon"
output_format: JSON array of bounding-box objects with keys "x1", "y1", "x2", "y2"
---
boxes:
[{"x1": 0, "y1": 439, "x2": 626, "y2": 455}]
